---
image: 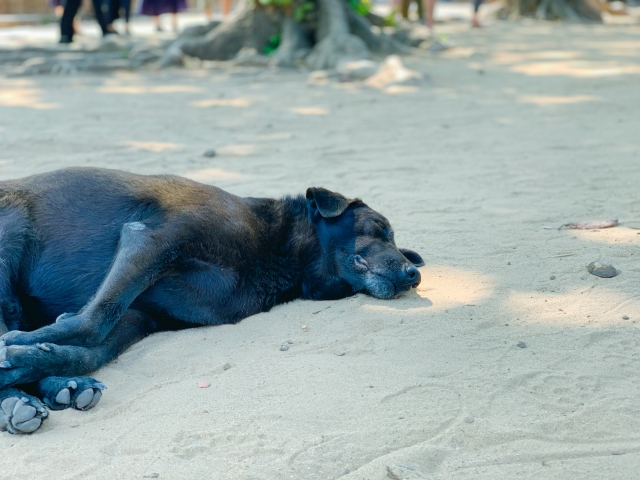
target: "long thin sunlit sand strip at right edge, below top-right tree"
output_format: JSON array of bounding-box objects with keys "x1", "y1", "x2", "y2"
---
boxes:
[{"x1": 511, "y1": 62, "x2": 640, "y2": 78}]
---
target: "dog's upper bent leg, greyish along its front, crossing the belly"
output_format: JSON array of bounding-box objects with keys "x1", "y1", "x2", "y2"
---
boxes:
[{"x1": 0, "y1": 222, "x2": 181, "y2": 348}]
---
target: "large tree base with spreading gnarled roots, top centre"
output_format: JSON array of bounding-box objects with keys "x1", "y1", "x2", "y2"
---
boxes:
[{"x1": 172, "y1": 0, "x2": 413, "y2": 70}]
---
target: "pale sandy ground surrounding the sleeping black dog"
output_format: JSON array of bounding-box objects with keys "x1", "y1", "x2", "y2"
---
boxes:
[{"x1": 0, "y1": 19, "x2": 640, "y2": 480}]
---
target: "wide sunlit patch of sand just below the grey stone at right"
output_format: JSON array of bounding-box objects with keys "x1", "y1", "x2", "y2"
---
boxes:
[{"x1": 506, "y1": 288, "x2": 640, "y2": 326}]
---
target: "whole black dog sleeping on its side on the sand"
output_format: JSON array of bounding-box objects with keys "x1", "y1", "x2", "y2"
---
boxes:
[{"x1": 0, "y1": 169, "x2": 423, "y2": 433}]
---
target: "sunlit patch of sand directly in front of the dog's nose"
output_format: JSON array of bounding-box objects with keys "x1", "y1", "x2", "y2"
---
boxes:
[{"x1": 417, "y1": 265, "x2": 496, "y2": 310}]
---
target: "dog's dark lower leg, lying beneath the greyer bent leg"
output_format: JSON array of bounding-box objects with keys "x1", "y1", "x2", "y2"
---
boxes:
[{"x1": 0, "y1": 310, "x2": 156, "y2": 390}]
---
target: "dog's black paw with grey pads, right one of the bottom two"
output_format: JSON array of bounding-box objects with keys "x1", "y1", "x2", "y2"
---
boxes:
[{"x1": 38, "y1": 377, "x2": 107, "y2": 410}]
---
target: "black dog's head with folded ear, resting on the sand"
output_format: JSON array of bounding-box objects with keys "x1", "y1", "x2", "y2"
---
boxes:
[{"x1": 306, "y1": 188, "x2": 424, "y2": 298}]
